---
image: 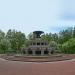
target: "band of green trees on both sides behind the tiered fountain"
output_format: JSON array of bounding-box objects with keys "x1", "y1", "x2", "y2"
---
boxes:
[{"x1": 0, "y1": 27, "x2": 75, "y2": 53}]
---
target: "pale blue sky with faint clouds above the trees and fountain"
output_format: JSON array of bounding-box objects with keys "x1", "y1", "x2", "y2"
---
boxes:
[{"x1": 0, "y1": 0, "x2": 75, "y2": 34}]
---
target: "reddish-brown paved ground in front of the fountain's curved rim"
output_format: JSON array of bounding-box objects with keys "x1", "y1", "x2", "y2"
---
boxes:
[{"x1": 0, "y1": 58, "x2": 75, "y2": 75}]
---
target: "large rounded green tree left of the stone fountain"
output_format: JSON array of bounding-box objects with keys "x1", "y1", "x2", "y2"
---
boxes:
[{"x1": 6, "y1": 30, "x2": 26, "y2": 50}]
